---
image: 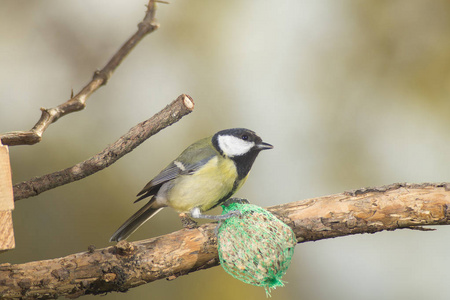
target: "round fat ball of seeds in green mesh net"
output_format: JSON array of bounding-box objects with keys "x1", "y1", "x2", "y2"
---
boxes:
[{"x1": 217, "y1": 203, "x2": 297, "y2": 296}]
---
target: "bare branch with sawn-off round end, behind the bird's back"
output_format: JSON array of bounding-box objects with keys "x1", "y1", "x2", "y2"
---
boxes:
[{"x1": 13, "y1": 94, "x2": 194, "y2": 201}]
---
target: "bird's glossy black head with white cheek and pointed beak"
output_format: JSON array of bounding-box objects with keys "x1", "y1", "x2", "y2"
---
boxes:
[{"x1": 212, "y1": 128, "x2": 273, "y2": 178}]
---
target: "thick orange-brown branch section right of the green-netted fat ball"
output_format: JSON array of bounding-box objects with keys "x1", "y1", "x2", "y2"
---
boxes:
[{"x1": 270, "y1": 183, "x2": 450, "y2": 242}]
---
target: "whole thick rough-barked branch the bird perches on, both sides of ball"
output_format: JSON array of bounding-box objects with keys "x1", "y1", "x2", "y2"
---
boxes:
[{"x1": 0, "y1": 184, "x2": 450, "y2": 299}]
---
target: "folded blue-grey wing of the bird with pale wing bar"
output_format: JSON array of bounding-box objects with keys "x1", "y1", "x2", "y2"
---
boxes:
[{"x1": 134, "y1": 154, "x2": 214, "y2": 202}]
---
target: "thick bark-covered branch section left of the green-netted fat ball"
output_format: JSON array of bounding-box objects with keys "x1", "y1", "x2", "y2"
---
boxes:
[{"x1": 0, "y1": 224, "x2": 217, "y2": 299}]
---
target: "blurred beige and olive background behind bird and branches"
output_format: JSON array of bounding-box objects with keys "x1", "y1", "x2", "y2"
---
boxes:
[{"x1": 0, "y1": 0, "x2": 450, "y2": 300}]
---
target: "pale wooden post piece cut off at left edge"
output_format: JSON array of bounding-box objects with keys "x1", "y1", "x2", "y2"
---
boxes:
[{"x1": 0, "y1": 141, "x2": 15, "y2": 251}]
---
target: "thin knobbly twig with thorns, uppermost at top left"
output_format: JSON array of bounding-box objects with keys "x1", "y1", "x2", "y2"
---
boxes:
[{"x1": 0, "y1": 0, "x2": 159, "y2": 146}]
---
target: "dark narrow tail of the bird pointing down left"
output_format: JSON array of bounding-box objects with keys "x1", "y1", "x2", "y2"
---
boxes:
[{"x1": 109, "y1": 198, "x2": 162, "y2": 242}]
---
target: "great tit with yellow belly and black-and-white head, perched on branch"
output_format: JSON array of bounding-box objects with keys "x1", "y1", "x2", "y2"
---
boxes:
[{"x1": 110, "y1": 128, "x2": 273, "y2": 242}]
